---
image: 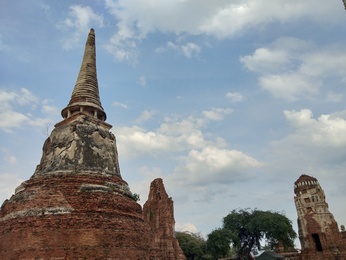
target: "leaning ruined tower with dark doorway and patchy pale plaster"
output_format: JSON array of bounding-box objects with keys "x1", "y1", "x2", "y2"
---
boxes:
[{"x1": 294, "y1": 175, "x2": 346, "y2": 260}]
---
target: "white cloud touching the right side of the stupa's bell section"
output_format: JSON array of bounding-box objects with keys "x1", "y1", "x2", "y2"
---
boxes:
[{"x1": 115, "y1": 108, "x2": 232, "y2": 159}]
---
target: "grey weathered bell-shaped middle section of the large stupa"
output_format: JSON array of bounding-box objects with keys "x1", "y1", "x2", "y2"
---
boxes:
[{"x1": 33, "y1": 119, "x2": 121, "y2": 177}]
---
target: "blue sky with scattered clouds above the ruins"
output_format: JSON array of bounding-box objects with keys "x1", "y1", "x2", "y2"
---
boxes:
[{"x1": 0, "y1": 0, "x2": 346, "y2": 248}]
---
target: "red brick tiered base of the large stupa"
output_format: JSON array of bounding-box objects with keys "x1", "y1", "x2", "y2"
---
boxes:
[{"x1": 0, "y1": 174, "x2": 152, "y2": 259}]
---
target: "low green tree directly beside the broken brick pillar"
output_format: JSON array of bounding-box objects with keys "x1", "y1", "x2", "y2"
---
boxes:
[{"x1": 175, "y1": 232, "x2": 207, "y2": 260}]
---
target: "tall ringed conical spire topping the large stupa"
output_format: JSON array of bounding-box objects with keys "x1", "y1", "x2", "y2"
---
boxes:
[{"x1": 61, "y1": 29, "x2": 107, "y2": 121}]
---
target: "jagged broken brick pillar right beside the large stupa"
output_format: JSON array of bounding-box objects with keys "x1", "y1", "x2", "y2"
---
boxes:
[{"x1": 143, "y1": 178, "x2": 186, "y2": 259}]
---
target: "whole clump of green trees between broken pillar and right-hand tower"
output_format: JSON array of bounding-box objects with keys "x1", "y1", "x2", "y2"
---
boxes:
[{"x1": 176, "y1": 209, "x2": 297, "y2": 260}]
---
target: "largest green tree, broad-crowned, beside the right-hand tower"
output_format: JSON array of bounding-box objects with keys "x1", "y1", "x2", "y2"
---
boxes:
[{"x1": 223, "y1": 209, "x2": 297, "y2": 259}]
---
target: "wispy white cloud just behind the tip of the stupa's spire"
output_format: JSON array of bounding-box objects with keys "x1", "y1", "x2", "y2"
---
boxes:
[{"x1": 58, "y1": 5, "x2": 103, "y2": 49}]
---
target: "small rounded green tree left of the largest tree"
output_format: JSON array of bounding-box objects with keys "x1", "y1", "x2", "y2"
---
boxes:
[{"x1": 207, "y1": 228, "x2": 231, "y2": 259}]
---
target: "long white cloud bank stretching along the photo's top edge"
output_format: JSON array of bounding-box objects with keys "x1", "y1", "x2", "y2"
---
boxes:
[{"x1": 106, "y1": 0, "x2": 341, "y2": 38}]
